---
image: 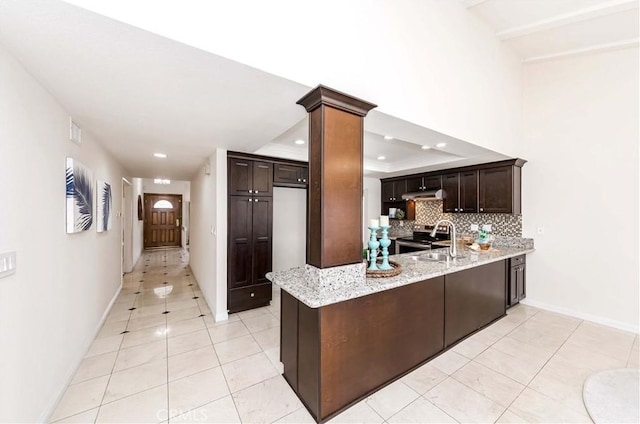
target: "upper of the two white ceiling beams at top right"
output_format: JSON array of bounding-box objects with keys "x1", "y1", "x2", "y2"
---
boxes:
[{"x1": 496, "y1": 0, "x2": 638, "y2": 40}]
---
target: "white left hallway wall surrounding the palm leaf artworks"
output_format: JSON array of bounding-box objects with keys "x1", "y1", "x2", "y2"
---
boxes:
[{"x1": 0, "y1": 41, "x2": 126, "y2": 422}]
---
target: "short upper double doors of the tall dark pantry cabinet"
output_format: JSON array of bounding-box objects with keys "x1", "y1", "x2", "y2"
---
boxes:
[{"x1": 228, "y1": 157, "x2": 273, "y2": 197}]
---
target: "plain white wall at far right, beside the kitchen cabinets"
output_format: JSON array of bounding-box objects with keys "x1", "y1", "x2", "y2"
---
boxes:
[{"x1": 518, "y1": 48, "x2": 640, "y2": 332}]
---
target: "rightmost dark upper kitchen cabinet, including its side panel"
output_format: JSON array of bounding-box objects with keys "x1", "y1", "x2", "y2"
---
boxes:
[{"x1": 478, "y1": 163, "x2": 522, "y2": 214}]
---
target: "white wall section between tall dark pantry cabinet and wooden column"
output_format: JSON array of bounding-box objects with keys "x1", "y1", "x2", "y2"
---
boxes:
[{"x1": 272, "y1": 187, "x2": 307, "y2": 271}]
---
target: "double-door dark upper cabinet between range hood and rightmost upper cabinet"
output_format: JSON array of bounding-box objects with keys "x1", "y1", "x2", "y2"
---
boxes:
[{"x1": 442, "y1": 170, "x2": 478, "y2": 213}]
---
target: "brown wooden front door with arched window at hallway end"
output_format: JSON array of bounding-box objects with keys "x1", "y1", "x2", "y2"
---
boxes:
[{"x1": 144, "y1": 193, "x2": 182, "y2": 249}]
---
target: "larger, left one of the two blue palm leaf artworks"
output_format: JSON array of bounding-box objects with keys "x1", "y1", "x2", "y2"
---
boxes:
[{"x1": 66, "y1": 158, "x2": 93, "y2": 233}]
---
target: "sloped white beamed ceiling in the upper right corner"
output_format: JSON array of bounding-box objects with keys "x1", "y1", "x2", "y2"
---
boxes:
[{"x1": 460, "y1": 0, "x2": 639, "y2": 62}]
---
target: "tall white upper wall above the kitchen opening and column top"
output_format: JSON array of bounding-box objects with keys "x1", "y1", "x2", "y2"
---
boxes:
[{"x1": 69, "y1": 0, "x2": 522, "y2": 155}]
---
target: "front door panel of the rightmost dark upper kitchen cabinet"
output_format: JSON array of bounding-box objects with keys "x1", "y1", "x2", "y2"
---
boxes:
[{"x1": 479, "y1": 166, "x2": 513, "y2": 213}]
